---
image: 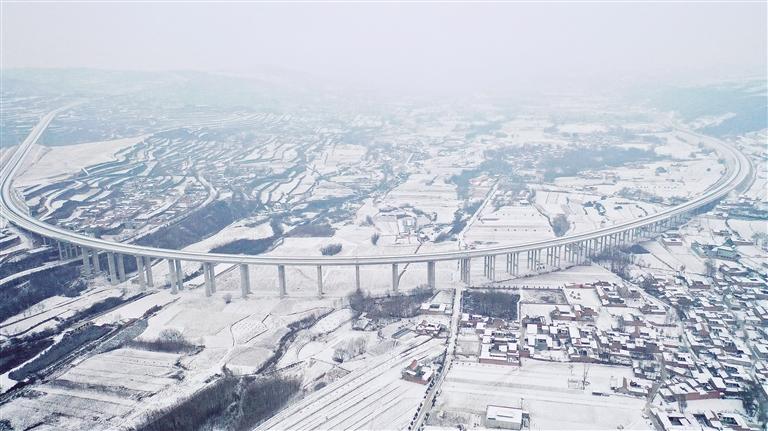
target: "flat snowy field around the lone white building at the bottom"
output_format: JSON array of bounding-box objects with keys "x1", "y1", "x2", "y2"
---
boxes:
[{"x1": 432, "y1": 359, "x2": 652, "y2": 430}]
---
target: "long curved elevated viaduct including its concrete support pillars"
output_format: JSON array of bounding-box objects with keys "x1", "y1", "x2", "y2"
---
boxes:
[{"x1": 0, "y1": 107, "x2": 751, "y2": 296}]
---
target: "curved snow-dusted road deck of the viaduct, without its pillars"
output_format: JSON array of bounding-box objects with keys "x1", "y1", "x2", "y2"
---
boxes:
[{"x1": 0, "y1": 107, "x2": 750, "y2": 266}]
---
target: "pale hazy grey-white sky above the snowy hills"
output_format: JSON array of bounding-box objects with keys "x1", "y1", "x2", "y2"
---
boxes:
[{"x1": 2, "y1": 2, "x2": 767, "y2": 93}]
